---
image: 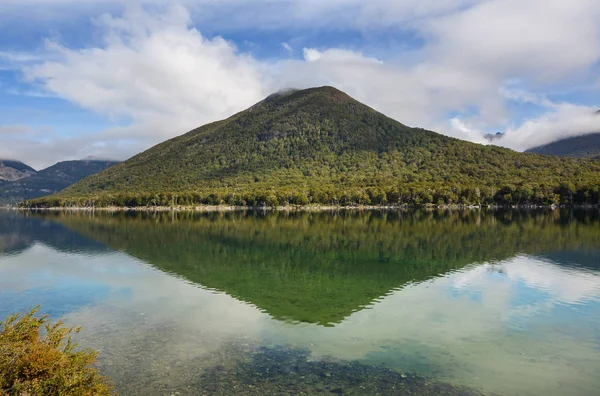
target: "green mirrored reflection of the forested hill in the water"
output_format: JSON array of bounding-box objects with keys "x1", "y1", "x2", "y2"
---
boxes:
[{"x1": 44, "y1": 211, "x2": 600, "y2": 326}]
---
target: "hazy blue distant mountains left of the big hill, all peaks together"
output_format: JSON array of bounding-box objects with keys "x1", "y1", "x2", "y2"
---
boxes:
[{"x1": 0, "y1": 160, "x2": 117, "y2": 205}]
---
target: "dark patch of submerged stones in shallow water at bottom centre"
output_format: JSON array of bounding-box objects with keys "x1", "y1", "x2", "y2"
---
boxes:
[{"x1": 198, "y1": 347, "x2": 482, "y2": 396}]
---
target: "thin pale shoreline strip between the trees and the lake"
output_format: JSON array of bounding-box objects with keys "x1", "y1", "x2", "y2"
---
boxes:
[{"x1": 10, "y1": 205, "x2": 600, "y2": 212}]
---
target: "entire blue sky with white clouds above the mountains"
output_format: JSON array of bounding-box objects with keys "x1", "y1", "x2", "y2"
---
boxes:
[{"x1": 0, "y1": 0, "x2": 600, "y2": 169}]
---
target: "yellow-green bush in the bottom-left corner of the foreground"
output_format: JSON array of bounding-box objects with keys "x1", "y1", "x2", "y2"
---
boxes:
[{"x1": 0, "y1": 308, "x2": 112, "y2": 396}]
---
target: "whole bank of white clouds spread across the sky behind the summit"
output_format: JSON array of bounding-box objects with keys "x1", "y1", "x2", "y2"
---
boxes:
[{"x1": 0, "y1": 0, "x2": 600, "y2": 164}]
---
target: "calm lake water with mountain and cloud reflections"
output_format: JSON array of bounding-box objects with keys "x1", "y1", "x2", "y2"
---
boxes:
[{"x1": 0, "y1": 211, "x2": 600, "y2": 395}]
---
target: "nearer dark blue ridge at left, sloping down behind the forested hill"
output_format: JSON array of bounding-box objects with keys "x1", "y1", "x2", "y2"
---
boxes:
[{"x1": 0, "y1": 160, "x2": 116, "y2": 204}]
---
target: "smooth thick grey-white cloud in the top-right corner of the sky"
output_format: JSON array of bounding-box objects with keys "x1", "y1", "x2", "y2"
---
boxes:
[{"x1": 425, "y1": 0, "x2": 600, "y2": 80}]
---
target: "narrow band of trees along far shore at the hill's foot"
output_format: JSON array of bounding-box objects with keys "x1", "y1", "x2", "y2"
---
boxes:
[{"x1": 21, "y1": 182, "x2": 600, "y2": 209}]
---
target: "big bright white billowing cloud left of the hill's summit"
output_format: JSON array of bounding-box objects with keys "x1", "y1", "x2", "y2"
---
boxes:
[{"x1": 25, "y1": 3, "x2": 266, "y2": 142}]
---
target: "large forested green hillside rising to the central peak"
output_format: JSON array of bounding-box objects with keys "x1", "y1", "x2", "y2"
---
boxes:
[{"x1": 27, "y1": 87, "x2": 600, "y2": 207}]
